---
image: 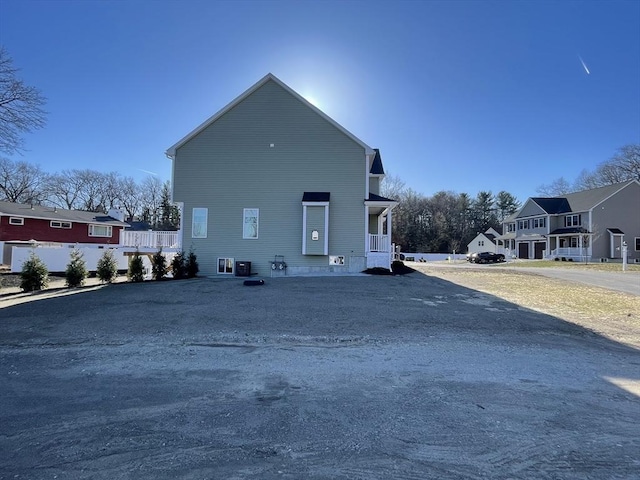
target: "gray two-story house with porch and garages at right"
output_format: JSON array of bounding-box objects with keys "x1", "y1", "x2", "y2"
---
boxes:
[{"x1": 498, "y1": 180, "x2": 640, "y2": 261}]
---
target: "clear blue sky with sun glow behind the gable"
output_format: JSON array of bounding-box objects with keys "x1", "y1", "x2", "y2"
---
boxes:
[{"x1": 0, "y1": 0, "x2": 640, "y2": 200}]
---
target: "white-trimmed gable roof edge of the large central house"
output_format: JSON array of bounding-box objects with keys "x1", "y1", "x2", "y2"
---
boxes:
[{"x1": 165, "y1": 73, "x2": 374, "y2": 159}]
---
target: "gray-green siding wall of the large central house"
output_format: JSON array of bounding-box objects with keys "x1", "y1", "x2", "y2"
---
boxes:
[{"x1": 174, "y1": 81, "x2": 366, "y2": 275}]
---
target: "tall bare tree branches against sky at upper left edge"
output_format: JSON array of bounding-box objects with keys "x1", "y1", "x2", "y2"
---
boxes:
[{"x1": 0, "y1": 46, "x2": 46, "y2": 154}]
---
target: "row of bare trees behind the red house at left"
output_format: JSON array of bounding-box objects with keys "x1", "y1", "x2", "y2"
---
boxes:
[{"x1": 0, "y1": 157, "x2": 180, "y2": 230}]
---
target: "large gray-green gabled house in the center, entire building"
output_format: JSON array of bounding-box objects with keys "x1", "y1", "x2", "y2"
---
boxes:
[{"x1": 166, "y1": 74, "x2": 397, "y2": 275}]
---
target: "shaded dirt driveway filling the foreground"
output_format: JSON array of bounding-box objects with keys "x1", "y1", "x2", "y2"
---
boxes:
[{"x1": 0, "y1": 272, "x2": 640, "y2": 480}]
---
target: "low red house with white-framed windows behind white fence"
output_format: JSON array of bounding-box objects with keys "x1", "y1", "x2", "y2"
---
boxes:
[{"x1": 0, "y1": 202, "x2": 127, "y2": 264}]
